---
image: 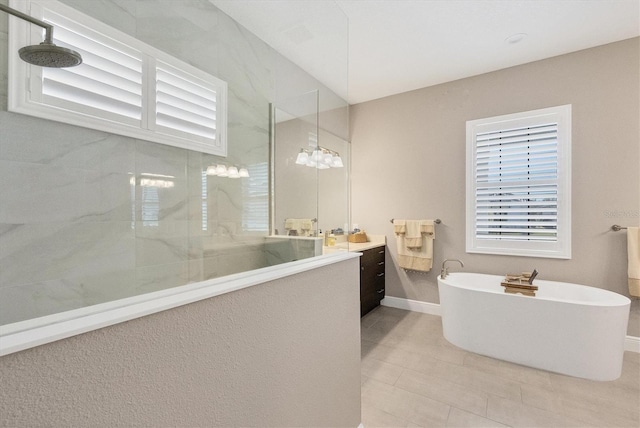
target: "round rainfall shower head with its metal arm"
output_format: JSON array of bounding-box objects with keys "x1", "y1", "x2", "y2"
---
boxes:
[{"x1": 0, "y1": 4, "x2": 82, "y2": 68}]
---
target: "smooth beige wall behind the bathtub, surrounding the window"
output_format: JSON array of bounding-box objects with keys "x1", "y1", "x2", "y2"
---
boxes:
[{"x1": 350, "y1": 38, "x2": 640, "y2": 336}]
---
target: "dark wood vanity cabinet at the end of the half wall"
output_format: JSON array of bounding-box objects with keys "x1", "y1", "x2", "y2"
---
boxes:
[{"x1": 360, "y1": 246, "x2": 385, "y2": 317}]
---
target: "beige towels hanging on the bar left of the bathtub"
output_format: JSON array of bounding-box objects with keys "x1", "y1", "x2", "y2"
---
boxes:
[{"x1": 393, "y1": 220, "x2": 435, "y2": 272}]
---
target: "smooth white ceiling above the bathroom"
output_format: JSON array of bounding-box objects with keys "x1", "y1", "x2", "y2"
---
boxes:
[{"x1": 210, "y1": 0, "x2": 640, "y2": 104}]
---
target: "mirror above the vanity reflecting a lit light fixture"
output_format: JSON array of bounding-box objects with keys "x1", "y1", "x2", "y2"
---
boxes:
[{"x1": 272, "y1": 91, "x2": 350, "y2": 255}]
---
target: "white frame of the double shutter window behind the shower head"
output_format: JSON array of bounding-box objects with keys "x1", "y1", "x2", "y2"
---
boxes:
[{"x1": 8, "y1": 0, "x2": 228, "y2": 157}]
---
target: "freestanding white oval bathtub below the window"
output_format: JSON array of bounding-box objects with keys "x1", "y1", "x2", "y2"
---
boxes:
[{"x1": 438, "y1": 272, "x2": 631, "y2": 381}]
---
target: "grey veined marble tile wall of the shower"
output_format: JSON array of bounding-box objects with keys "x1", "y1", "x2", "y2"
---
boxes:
[{"x1": 0, "y1": 0, "x2": 348, "y2": 324}]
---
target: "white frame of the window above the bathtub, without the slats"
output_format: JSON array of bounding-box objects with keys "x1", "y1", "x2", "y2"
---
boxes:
[{"x1": 466, "y1": 104, "x2": 571, "y2": 259}]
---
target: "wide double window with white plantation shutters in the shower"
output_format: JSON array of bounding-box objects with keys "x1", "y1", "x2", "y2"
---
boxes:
[{"x1": 9, "y1": 0, "x2": 227, "y2": 156}]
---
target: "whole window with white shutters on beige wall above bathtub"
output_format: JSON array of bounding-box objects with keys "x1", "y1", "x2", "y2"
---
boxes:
[{"x1": 467, "y1": 105, "x2": 571, "y2": 258}]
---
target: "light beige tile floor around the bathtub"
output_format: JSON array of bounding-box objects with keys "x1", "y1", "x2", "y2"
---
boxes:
[{"x1": 361, "y1": 306, "x2": 640, "y2": 428}]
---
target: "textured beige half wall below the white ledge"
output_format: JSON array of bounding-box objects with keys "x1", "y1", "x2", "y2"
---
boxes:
[{"x1": 0, "y1": 258, "x2": 360, "y2": 428}]
